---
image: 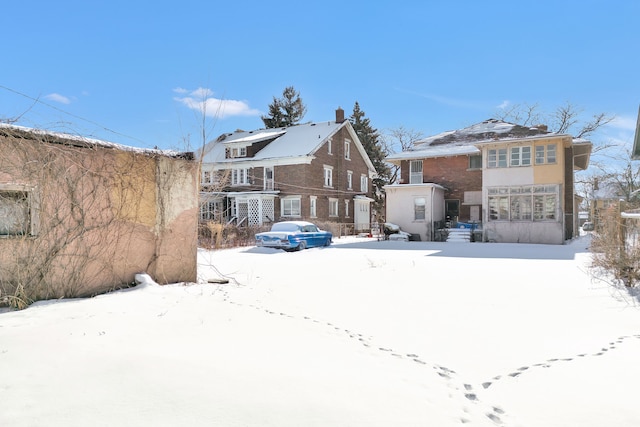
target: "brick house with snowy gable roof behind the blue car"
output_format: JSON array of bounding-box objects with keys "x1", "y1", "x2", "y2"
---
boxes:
[{"x1": 199, "y1": 109, "x2": 375, "y2": 231}]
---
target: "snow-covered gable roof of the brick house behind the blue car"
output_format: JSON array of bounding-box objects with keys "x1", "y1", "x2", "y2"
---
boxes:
[{"x1": 199, "y1": 120, "x2": 375, "y2": 171}]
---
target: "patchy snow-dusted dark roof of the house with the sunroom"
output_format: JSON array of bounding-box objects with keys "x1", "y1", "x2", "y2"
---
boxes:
[{"x1": 387, "y1": 119, "x2": 558, "y2": 161}]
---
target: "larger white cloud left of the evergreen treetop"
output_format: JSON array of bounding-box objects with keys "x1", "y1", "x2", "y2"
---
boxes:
[{"x1": 174, "y1": 87, "x2": 260, "y2": 119}]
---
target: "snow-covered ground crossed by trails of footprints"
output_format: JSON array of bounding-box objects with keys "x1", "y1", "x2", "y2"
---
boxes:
[{"x1": 0, "y1": 238, "x2": 640, "y2": 427}]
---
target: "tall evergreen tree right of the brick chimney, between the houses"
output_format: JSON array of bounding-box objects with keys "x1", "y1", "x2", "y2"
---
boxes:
[{"x1": 349, "y1": 101, "x2": 391, "y2": 217}]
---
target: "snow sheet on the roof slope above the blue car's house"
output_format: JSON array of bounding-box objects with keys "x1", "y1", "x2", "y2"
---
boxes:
[{"x1": 203, "y1": 121, "x2": 348, "y2": 163}]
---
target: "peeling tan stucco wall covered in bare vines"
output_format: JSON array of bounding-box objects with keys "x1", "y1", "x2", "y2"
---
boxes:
[{"x1": 0, "y1": 130, "x2": 198, "y2": 299}]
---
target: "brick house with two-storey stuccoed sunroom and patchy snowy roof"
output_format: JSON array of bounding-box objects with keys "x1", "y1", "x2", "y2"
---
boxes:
[{"x1": 386, "y1": 119, "x2": 591, "y2": 243}]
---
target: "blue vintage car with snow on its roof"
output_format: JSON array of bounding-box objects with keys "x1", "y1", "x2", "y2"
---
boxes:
[{"x1": 256, "y1": 221, "x2": 333, "y2": 251}]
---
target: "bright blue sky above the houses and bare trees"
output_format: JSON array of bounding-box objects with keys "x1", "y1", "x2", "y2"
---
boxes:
[{"x1": 0, "y1": 0, "x2": 640, "y2": 158}]
